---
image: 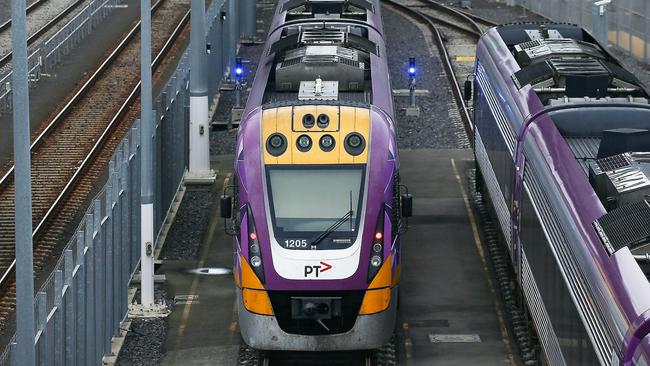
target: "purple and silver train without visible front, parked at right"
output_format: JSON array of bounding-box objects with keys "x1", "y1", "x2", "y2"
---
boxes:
[{"x1": 472, "y1": 23, "x2": 650, "y2": 365}]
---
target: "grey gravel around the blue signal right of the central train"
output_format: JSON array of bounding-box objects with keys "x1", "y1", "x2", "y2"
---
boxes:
[{"x1": 382, "y1": 6, "x2": 469, "y2": 149}]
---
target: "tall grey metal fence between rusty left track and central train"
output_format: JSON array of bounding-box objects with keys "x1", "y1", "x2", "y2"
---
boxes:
[{"x1": 0, "y1": 0, "x2": 239, "y2": 366}]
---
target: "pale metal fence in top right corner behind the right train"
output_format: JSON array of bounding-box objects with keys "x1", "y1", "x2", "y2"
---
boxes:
[{"x1": 516, "y1": 0, "x2": 650, "y2": 63}]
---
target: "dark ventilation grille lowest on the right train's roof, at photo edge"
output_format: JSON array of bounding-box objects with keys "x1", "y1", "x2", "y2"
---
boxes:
[{"x1": 594, "y1": 201, "x2": 650, "y2": 255}]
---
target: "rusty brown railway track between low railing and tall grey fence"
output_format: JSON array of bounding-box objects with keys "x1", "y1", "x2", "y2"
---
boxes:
[{"x1": 0, "y1": 0, "x2": 189, "y2": 326}]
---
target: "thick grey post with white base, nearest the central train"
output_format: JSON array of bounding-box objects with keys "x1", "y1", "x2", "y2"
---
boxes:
[{"x1": 188, "y1": 0, "x2": 214, "y2": 183}]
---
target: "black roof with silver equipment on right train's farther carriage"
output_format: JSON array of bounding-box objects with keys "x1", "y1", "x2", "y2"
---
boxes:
[{"x1": 497, "y1": 23, "x2": 649, "y2": 106}]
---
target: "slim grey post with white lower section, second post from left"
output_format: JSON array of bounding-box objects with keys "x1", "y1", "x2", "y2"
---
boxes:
[{"x1": 140, "y1": 0, "x2": 154, "y2": 306}]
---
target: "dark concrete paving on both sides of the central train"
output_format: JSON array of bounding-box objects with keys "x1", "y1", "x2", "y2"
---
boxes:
[{"x1": 158, "y1": 150, "x2": 519, "y2": 365}]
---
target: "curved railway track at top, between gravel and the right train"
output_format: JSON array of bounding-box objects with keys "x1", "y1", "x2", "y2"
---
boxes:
[{"x1": 383, "y1": 0, "x2": 496, "y2": 142}]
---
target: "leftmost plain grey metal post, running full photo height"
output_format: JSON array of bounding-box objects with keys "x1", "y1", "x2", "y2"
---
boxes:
[{"x1": 11, "y1": 0, "x2": 36, "y2": 366}]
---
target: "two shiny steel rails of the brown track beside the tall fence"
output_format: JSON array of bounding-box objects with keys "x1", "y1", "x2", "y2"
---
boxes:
[{"x1": 0, "y1": 0, "x2": 190, "y2": 288}]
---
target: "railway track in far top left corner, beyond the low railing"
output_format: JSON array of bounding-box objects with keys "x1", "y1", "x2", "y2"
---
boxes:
[{"x1": 0, "y1": 0, "x2": 87, "y2": 69}]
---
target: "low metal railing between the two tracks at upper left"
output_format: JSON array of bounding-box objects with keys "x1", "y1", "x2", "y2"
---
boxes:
[{"x1": 0, "y1": 0, "x2": 122, "y2": 115}]
